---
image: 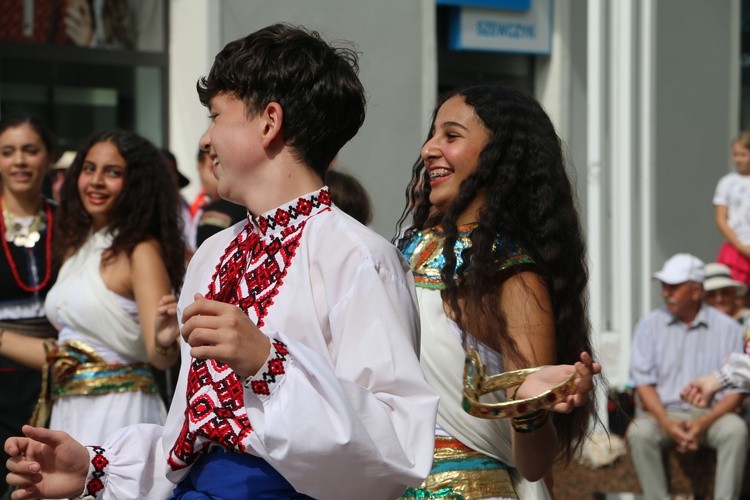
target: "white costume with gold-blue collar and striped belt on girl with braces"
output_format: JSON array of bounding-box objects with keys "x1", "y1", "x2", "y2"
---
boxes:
[{"x1": 401, "y1": 225, "x2": 550, "y2": 500}]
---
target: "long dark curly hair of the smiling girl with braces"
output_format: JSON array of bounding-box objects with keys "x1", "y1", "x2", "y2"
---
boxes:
[{"x1": 400, "y1": 86, "x2": 595, "y2": 460}]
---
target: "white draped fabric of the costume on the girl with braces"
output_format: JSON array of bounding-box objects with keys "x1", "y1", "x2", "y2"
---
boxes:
[{"x1": 417, "y1": 287, "x2": 550, "y2": 500}]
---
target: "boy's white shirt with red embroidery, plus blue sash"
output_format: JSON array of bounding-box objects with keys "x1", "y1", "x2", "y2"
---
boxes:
[{"x1": 73, "y1": 188, "x2": 437, "y2": 499}]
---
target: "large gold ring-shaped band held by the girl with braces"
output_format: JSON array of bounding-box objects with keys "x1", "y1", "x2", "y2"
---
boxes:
[{"x1": 462, "y1": 349, "x2": 577, "y2": 418}]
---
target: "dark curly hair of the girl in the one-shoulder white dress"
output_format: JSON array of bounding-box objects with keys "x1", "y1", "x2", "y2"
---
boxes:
[{"x1": 54, "y1": 130, "x2": 185, "y2": 291}]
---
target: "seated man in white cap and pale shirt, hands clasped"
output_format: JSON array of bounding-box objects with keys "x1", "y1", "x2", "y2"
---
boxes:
[{"x1": 626, "y1": 254, "x2": 747, "y2": 499}]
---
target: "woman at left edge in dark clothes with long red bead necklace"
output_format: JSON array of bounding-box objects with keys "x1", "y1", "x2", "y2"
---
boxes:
[{"x1": 0, "y1": 116, "x2": 55, "y2": 495}]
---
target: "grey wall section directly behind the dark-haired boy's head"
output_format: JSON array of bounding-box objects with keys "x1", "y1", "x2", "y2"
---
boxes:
[{"x1": 220, "y1": 0, "x2": 435, "y2": 238}]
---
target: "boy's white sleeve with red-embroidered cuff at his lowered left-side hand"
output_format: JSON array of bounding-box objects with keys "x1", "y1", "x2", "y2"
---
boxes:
[{"x1": 79, "y1": 424, "x2": 174, "y2": 500}]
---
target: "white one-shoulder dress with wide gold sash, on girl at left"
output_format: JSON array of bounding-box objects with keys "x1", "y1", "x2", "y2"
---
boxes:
[{"x1": 45, "y1": 228, "x2": 166, "y2": 444}]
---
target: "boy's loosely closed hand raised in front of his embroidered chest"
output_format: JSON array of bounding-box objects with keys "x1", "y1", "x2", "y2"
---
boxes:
[{"x1": 180, "y1": 293, "x2": 271, "y2": 379}]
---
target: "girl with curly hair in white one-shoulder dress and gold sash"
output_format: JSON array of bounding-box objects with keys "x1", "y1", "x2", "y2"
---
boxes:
[{"x1": 0, "y1": 131, "x2": 184, "y2": 443}]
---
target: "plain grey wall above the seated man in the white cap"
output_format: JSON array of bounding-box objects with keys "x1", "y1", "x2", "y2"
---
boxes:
[{"x1": 652, "y1": 0, "x2": 740, "y2": 305}]
